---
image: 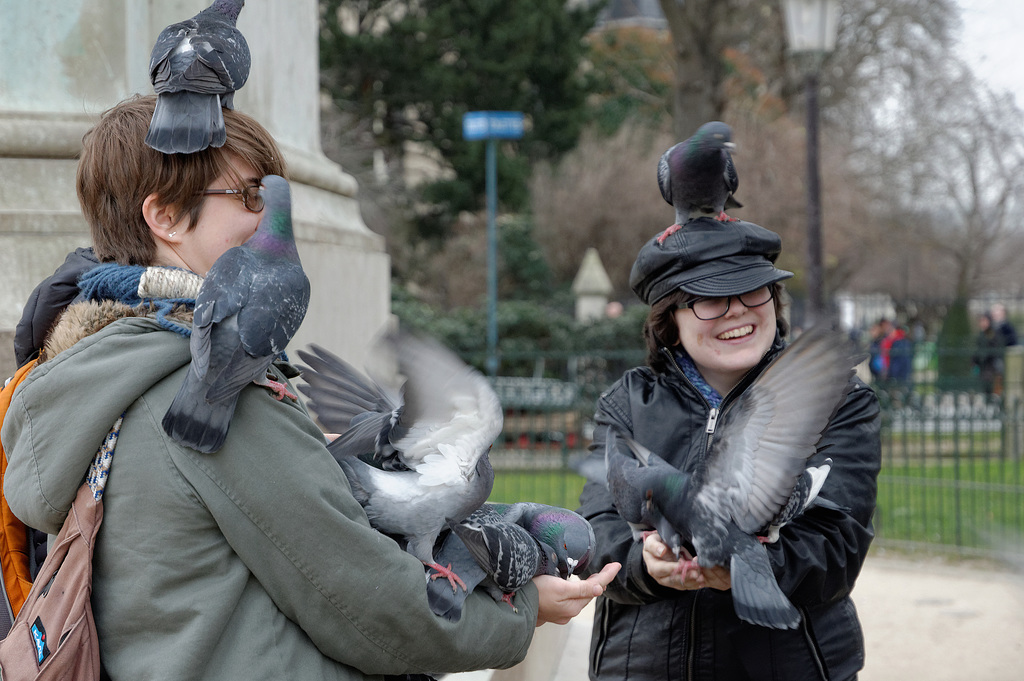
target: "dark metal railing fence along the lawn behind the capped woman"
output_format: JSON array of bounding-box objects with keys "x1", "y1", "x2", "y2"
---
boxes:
[{"x1": 490, "y1": 348, "x2": 1024, "y2": 557}]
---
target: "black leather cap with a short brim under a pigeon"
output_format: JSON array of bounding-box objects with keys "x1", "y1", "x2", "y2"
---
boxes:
[{"x1": 630, "y1": 217, "x2": 793, "y2": 305}]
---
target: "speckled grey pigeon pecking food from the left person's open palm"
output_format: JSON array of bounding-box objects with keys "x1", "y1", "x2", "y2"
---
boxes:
[{"x1": 427, "y1": 502, "x2": 595, "y2": 622}]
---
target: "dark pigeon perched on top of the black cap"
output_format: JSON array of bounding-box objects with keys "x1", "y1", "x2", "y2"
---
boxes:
[{"x1": 657, "y1": 121, "x2": 742, "y2": 225}]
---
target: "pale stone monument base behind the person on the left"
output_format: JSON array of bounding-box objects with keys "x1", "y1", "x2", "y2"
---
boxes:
[{"x1": 0, "y1": 0, "x2": 390, "y2": 378}]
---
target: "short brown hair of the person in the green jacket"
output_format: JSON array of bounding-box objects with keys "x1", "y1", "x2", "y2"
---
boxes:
[{"x1": 76, "y1": 95, "x2": 285, "y2": 265}]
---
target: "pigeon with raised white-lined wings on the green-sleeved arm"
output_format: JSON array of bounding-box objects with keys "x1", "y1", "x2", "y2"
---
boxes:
[{"x1": 299, "y1": 334, "x2": 503, "y2": 586}]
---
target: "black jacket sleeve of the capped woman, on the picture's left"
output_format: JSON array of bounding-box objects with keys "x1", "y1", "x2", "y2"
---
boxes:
[{"x1": 579, "y1": 376, "x2": 681, "y2": 604}]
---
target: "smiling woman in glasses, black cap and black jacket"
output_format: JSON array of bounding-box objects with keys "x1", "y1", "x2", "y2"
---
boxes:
[{"x1": 580, "y1": 218, "x2": 881, "y2": 681}]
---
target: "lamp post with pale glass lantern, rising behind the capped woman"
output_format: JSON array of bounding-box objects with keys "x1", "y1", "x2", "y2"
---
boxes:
[{"x1": 782, "y1": 0, "x2": 840, "y2": 326}]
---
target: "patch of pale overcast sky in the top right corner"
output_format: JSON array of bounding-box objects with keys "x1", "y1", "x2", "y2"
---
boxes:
[{"x1": 957, "y1": 0, "x2": 1024, "y2": 108}]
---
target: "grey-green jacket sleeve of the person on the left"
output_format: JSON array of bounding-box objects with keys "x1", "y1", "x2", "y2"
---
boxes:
[{"x1": 179, "y1": 382, "x2": 538, "y2": 674}]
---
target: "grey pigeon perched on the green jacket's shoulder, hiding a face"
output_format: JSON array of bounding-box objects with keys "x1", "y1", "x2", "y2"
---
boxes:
[{"x1": 163, "y1": 175, "x2": 309, "y2": 454}]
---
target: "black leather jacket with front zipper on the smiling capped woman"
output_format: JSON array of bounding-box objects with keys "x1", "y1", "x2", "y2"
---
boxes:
[{"x1": 580, "y1": 338, "x2": 881, "y2": 681}]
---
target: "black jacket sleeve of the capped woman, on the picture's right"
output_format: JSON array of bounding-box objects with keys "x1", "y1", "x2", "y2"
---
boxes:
[{"x1": 768, "y1": 380, "x2": 882, "y2": 605}]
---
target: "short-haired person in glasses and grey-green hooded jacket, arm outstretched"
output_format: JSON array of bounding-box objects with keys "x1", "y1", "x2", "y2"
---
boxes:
[{"x1": 2, "y1": 96, "x2": 614, "y2": 681}]
